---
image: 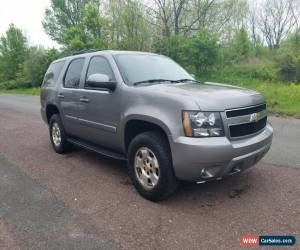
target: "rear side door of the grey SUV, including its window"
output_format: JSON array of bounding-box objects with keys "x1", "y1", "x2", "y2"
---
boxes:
[{"x1": 57, "y1": 58, "x2": 85, "y2": 136}]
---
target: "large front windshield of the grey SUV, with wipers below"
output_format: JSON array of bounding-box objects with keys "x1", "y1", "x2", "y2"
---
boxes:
[{"x1": 116, "y1": 54, "x2": 193, "y2": 85}]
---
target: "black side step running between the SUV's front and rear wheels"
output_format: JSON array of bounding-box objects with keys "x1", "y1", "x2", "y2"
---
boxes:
[{"x1": 67, "y1": 138, "x2": 127, "y2": 161}]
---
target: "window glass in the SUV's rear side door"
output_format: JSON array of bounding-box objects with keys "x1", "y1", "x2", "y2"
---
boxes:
[{"x1": 64, "y1": 58, "x2": 84, "y2": 88}]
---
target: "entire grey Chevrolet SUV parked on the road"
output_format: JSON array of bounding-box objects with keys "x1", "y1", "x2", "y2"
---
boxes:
[{"x1": 41, "y1": 51, "x2": 273, "y2": 201}]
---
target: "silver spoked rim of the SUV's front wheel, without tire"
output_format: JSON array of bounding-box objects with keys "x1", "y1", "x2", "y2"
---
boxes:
[{"x1": 134, "y1": 147, "x2": 159, "y2": 189}]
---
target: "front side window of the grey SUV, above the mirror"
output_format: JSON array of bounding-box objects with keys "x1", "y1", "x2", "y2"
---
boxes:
[{"x1": 86, "y1": 56, "x2": 115, "y2": 80}]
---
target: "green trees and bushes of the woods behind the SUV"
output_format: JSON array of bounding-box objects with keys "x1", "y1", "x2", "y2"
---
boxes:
[{"x1": 0, "y1": 0, "x2": 300, "y2": 112}]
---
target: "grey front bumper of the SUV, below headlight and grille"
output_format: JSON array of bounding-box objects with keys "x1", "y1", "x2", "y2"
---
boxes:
[{"x1": 171, "y1": 124, "x2": 273, "y2": 182}]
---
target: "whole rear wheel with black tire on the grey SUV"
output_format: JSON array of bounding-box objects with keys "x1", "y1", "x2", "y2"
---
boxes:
[{"x1": 49, "y1": 114, "x2": 71, "y2": 154}]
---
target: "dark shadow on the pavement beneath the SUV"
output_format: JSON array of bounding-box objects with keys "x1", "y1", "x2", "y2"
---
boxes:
[{"x1": 68, "y1": 147, "x2": 256, "y2": 207}]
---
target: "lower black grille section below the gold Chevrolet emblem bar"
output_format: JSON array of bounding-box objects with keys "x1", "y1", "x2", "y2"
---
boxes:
[{"x1": 229, "y1": 117, "x2": 267, "y2": 137}]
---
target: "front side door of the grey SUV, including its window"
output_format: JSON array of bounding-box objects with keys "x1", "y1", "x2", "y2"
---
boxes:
[{"x1": 75, "y1": 55, "x2": 121, "y2": 148}]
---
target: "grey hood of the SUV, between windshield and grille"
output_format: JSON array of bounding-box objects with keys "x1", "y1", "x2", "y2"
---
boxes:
[{"x1": 148, "y1": 82, "x2": 265, "y2": 111}]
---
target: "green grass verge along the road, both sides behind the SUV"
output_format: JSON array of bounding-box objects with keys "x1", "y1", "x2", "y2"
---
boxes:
[{"x1": 0, "y1": 81, "x2": 300, "y2": 119}]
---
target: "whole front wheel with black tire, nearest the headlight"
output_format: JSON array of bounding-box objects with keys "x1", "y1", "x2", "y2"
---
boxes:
[{"x1": 128, "y1": 132, "x2": 179, "y2": 201}]
